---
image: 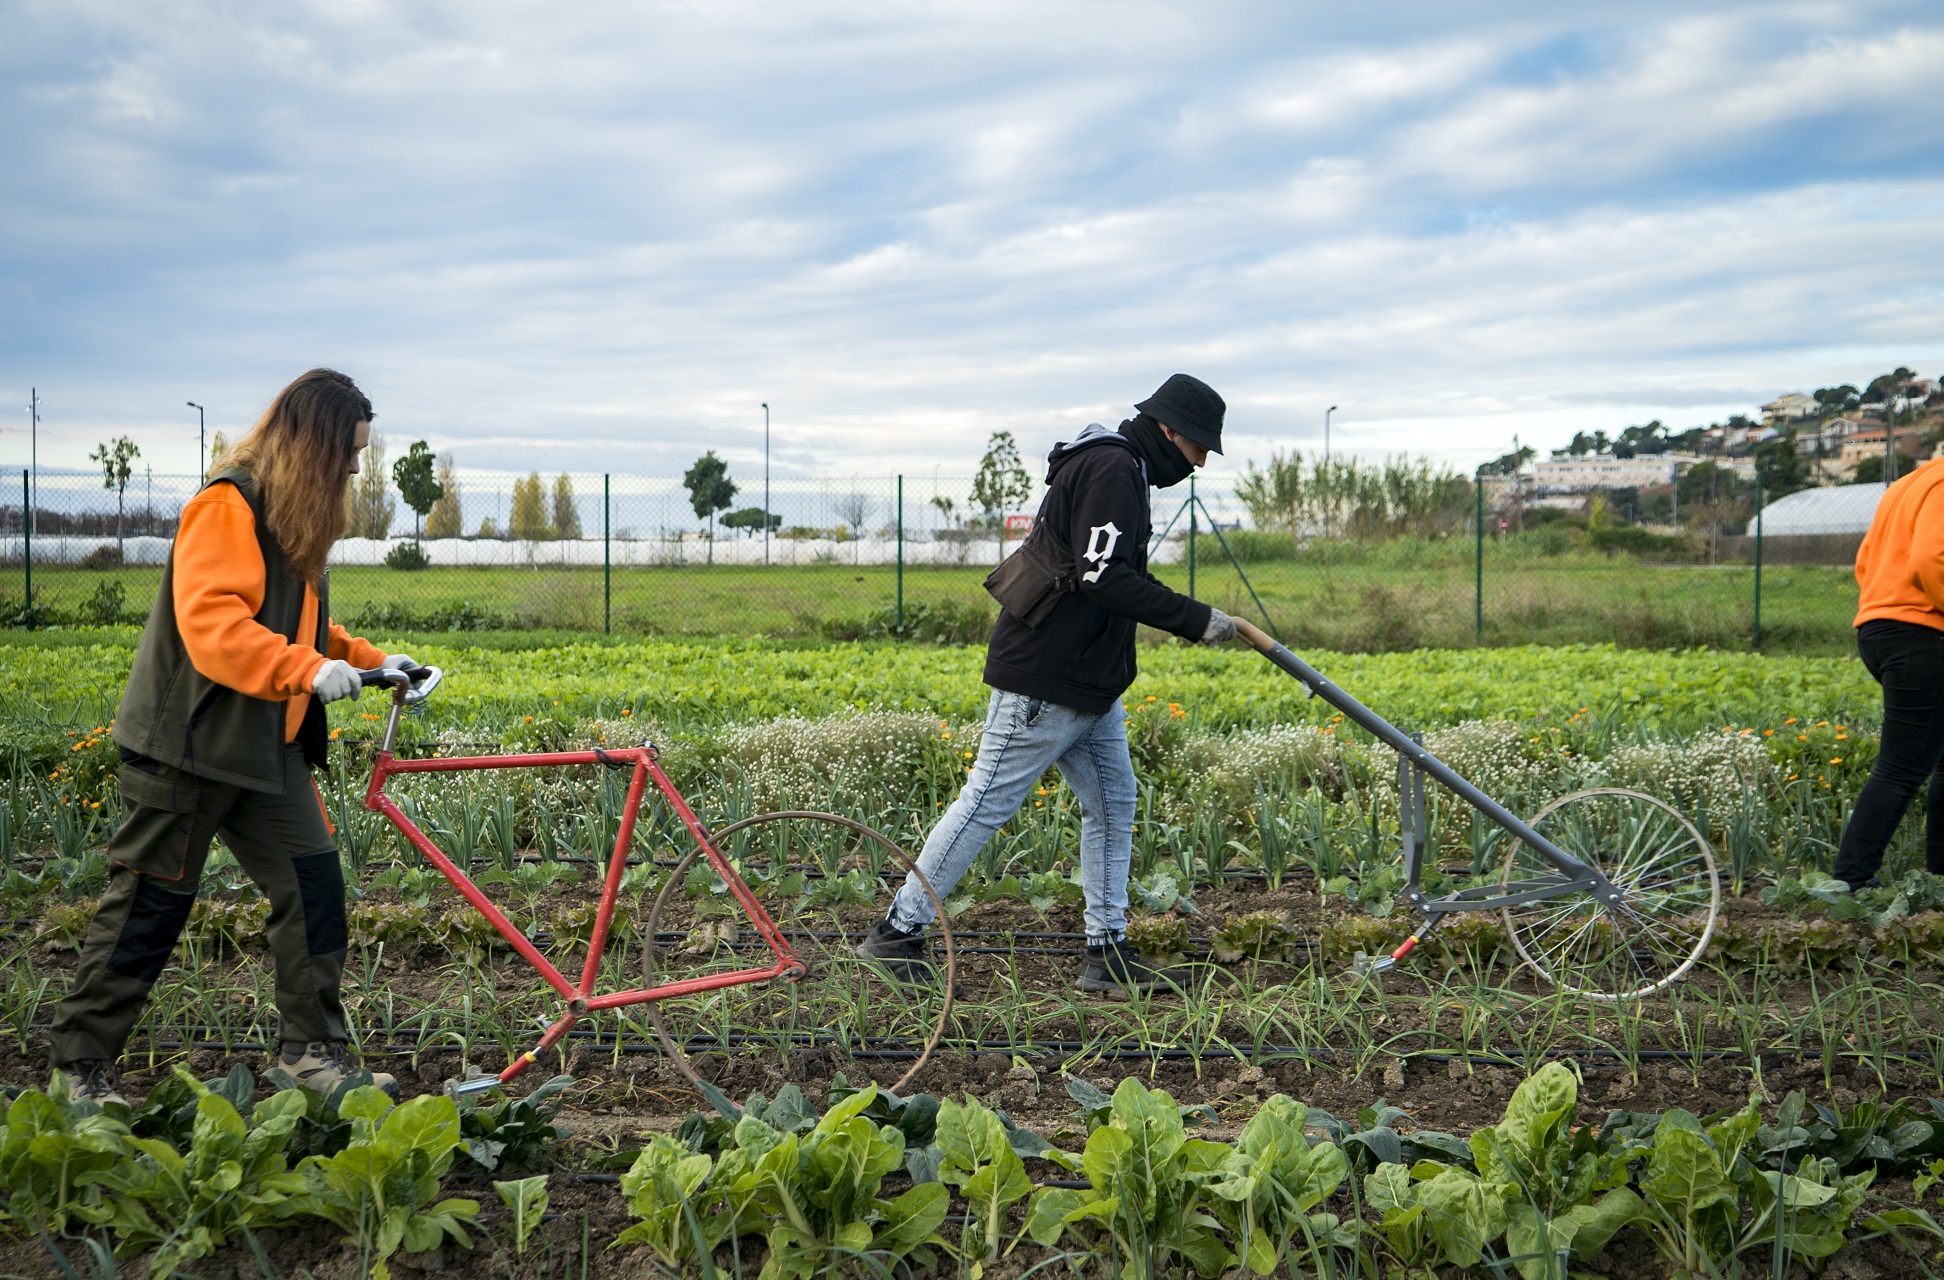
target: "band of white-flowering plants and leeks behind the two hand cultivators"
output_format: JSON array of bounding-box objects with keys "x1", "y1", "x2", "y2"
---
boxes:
[{"x1": 0, "y1": 669, "x2": 1912, "y2": 898}]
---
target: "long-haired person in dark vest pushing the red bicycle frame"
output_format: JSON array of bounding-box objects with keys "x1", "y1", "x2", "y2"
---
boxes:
[{"x1": 52, "y1": 370, "x2": 416, "y2": 1103}]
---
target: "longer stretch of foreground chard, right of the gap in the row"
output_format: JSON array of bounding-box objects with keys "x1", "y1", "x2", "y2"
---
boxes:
[{"x1": 616, "y1": 1062, "x2": 1944, "y2": 1280}]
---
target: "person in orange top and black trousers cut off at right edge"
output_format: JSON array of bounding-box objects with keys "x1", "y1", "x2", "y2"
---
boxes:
[{"x1": 1831, "y1": 463, "x2": 1944, "y2": 889}]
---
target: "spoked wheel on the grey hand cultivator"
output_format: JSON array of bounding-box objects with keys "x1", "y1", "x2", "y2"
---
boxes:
[{"x1": 1499, "y1": 788, "x2": 1720, "y2": 1002}]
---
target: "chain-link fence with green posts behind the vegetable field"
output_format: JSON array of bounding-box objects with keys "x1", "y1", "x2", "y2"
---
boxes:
[{"x1": 0, "y1": 469, "x2": 1882, "y2": 652}]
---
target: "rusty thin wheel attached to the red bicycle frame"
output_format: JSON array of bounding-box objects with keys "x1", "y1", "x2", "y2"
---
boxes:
[{"x1": 642, "y1": 809, "x2": 956, "y2": 1093}]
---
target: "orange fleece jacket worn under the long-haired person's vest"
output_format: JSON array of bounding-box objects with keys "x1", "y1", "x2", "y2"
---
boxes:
[{"x1": 175, "y1": 484, "x2": 385, "y2": 741}]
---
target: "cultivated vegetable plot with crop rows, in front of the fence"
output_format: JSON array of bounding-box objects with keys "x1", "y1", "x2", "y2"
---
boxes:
[{"x1": 0, "y1": 634, "x2": 1944, "y2": 1280}]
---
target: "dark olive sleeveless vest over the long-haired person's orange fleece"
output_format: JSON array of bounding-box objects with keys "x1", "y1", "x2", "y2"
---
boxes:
[{"x1": 115, "y1": 467, "x2": 330, "y2": 794}]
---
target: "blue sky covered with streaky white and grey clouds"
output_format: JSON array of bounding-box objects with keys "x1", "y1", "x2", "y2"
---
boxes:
[{"x1": 0, "y1": 0, "x2": 1944, "y2": 484}]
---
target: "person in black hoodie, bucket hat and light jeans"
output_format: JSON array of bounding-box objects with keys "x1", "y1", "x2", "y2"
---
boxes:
[{"x1": 857, "y1": 373, "x2": 1234, "y2": 994}]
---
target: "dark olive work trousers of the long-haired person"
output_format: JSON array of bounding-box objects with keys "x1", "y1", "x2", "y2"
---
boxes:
[{"x1": 52, "y1": 743, "x2": 348, "y2": 1066}]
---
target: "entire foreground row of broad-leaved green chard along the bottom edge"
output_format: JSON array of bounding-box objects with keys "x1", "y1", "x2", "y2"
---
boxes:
[{"x1": 11, "y1": 1062, "x2": 1944, "y2": 1280}]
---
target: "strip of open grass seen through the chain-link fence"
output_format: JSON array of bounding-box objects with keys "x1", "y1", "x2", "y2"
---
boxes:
[{"x1": 0, "y1": 539, "x2": 1857, "y2": 654}]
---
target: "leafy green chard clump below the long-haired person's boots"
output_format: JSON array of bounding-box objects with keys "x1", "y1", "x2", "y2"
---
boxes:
[{"x1": 0, "y1": 1066, "x2": 573, "y2": 1280}]
